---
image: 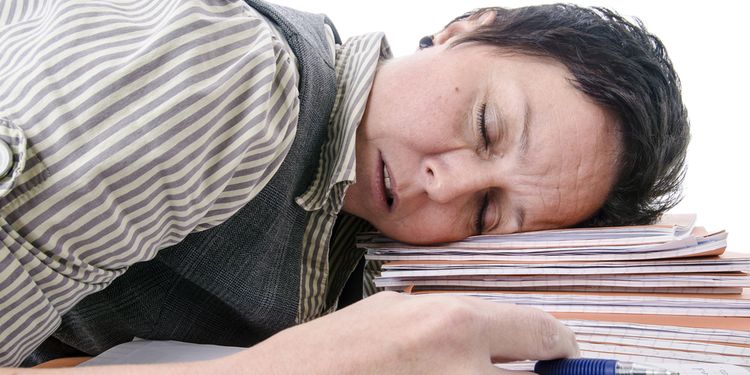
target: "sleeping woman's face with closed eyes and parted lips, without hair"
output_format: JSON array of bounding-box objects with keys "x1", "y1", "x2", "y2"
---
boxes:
[{"x1": 344, "y1": 40, "x2": 619, "y2": 243}]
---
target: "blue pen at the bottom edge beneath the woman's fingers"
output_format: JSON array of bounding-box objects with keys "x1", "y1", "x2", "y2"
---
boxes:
[{"x1": 534, "y1": 358, "x2": 680, "y2": 375}]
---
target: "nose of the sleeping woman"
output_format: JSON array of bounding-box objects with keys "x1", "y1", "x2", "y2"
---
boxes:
[{"x1": 420, "y1": 150, "x2": 493, "y2": 203}]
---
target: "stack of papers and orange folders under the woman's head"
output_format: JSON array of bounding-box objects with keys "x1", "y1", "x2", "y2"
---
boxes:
[{"x1": 358, "y1": 215, "x2": 750, "y2": 368}]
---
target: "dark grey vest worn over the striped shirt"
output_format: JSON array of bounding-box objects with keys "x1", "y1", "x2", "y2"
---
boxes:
[{"x1": 26, "y1": 0, "x2": 338, "y2": 364}]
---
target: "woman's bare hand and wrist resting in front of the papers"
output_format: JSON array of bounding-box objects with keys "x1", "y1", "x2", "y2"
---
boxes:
[{"x1": 222, "y1": 292, "x2": 578, "y2": 374}]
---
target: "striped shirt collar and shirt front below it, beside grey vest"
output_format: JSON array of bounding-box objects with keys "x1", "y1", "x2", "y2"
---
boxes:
[{"x1": 297, "y1": 33, "x2": 391, "y2": 322}]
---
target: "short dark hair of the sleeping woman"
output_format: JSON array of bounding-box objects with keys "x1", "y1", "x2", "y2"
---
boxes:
[{"x1": 452, "y1": 4, "x2": 690, "y2": 226}]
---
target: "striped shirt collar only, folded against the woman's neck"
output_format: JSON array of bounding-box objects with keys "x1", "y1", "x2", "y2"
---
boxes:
[{"x1": 296, "y1": 33, "x2": 391, "y2": 215}]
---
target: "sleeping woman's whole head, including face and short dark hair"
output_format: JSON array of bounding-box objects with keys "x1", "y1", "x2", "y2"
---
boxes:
[{"x1": 344, "y1": 6, "x2": 687, "y2": 243}]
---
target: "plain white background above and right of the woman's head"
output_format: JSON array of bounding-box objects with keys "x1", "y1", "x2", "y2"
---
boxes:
[{"x1": 276, "y1": 0, "x2": 750, "y2": 253}]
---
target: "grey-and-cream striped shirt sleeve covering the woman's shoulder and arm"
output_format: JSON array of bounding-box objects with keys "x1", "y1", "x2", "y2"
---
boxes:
[{"x1": 0, "y1": 0, "x2": 299, "y2": 366}]
